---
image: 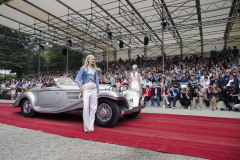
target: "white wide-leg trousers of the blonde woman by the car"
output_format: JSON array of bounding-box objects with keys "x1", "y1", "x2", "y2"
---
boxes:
[{"x1": 83, "y1": 82, "x2": 98, "y2": 132}]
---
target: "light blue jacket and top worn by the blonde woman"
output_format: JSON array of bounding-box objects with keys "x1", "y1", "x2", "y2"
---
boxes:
[{"x1": 75, "y1": 67, "x2": 99, "y2": 93}]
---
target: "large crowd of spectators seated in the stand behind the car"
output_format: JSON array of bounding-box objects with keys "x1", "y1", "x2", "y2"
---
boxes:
[{"x1": 0, "y1": 47, "x2": 240, "y2": 110}]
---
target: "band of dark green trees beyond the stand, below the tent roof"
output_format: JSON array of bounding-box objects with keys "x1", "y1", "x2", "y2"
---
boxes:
[{"x1": 0, "y1": 26, "x2": 82, "y2": 78}]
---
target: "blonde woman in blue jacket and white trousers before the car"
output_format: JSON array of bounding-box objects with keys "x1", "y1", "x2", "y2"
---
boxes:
[{"x1": 76, "y1": 55, "x2": 99, "y2": 132}]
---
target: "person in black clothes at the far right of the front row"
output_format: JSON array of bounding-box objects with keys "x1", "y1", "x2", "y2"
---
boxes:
[{"x1": 223, "y1": 82, "x2": 239, "y2": 111}]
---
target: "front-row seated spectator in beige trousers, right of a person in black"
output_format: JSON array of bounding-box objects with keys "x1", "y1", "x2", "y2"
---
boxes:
[{"x1": 191, "y1": 84, "x2": 204, "y2": 110}]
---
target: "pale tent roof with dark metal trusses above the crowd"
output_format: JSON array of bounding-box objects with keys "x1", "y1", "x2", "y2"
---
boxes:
[{"x1": 0, "y1": 0, "x2": 240, "y2": 54}]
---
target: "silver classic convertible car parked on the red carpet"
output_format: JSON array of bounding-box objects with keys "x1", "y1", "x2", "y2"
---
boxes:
[{"x1": 11, "y1": 78, "x2": 146, "y2": 127}]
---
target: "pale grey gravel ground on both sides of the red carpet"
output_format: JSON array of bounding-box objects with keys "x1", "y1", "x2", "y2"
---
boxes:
[{"x1": 0, "y1": 101, "x2": 240, "y2": 160}]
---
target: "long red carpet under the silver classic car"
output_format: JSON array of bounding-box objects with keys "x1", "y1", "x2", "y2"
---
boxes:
[{"x1": 0, "y1": 103, "x2": 240, "y2": 160}]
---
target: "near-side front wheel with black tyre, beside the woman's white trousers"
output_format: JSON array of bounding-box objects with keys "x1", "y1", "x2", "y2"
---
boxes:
[{"x1": 96, "y1": 99, "x2": 120, "y2": 127}]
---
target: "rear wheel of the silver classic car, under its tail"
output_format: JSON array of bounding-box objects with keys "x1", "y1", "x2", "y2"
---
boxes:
[{"x1": 21, "y1": 98, "x2": 36, "y2": 117}]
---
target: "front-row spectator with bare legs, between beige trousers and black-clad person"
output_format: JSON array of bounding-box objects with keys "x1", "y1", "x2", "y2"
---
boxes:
[{"x1": 208, "y1": 83, "x2": 219, "y2": 111}]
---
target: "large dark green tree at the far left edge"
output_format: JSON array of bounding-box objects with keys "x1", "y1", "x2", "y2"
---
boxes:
[{"x1": 0, "y1": 26, "x2": 33, "y2": 77}]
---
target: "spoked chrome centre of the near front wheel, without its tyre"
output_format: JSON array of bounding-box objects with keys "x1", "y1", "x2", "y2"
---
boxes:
[{"x1": 97, "y1": 103, "x2": 112, "y2": 122}]
